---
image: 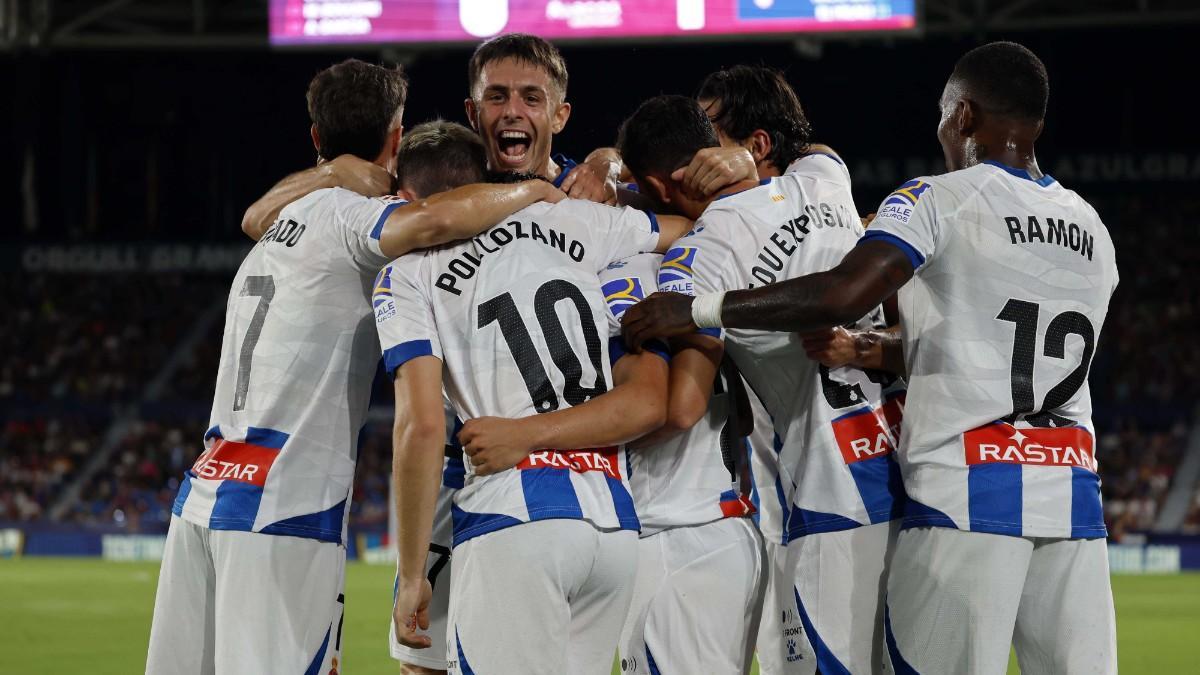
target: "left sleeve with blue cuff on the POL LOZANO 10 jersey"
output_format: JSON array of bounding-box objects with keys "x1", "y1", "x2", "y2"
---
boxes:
[{"x1": 371, "y1": 253, "x2": 442, "y2": 375}]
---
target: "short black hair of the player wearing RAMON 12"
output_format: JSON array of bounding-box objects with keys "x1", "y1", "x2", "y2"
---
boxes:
[{"x1": 950, "y1": 42, "x2": 1050, "y2": 121}]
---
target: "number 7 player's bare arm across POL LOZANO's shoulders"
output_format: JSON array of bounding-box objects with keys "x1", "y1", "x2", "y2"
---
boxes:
[{"x1": 379, "y1": 180, "x2": 566, "y2": 257}]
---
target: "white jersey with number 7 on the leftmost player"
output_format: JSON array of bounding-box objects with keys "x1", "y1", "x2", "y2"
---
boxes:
[{"x1": 173, "y1": 187, "x2": 404, "y2": 543}]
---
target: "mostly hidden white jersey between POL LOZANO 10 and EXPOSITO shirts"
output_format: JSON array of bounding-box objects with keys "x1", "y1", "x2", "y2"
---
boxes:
[{"x1": 600, "y1": 253, "x2": 761, "y2": 537}]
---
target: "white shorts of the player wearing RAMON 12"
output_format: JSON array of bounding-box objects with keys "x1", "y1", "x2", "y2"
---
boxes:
[{"x1": 887, "y1": 527, "x2": 1117, "y2": 675}]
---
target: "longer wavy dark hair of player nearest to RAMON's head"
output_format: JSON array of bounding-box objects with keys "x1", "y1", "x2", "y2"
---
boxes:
[{"x1": 696, "y1": 66, "x2": 812, "y2": 171}]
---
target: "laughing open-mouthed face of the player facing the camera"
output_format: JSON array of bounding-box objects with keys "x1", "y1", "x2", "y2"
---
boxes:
[{"x1": 467, "y1": 59, "x2": 571, "y2": 174}]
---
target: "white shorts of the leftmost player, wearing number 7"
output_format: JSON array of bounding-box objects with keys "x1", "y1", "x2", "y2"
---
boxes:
[{"x1": 146, "y1": 516, "x2": 346, "y2": 675}]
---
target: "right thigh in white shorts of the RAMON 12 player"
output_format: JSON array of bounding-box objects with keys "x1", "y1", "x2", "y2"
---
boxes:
[{"x1": 1013, "y1": 539, "x2": 1117, "y2": 675}]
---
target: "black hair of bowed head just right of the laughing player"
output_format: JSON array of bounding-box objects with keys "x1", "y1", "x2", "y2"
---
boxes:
[{"x1": 617, "y1": 95, "x2": 720, "y2": 180}]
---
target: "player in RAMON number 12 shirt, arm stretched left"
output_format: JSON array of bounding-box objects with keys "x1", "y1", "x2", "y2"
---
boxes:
[{"x1": 625, "y1": 42, "x2": 1117, "y2": 674}]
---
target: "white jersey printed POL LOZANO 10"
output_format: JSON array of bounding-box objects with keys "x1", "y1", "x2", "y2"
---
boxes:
[{"x1": 374, "y1": 199, "x2": 658, "y2": 545}]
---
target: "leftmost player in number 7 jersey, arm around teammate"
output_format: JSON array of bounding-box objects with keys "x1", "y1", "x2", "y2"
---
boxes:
[{"x1": 146, "y1": 60, "x2": 560, "y2": 674}]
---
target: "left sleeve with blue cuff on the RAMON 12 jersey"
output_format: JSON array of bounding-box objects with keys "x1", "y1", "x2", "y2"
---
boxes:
[{"x1": 858, "y1": 178, "x2": 941, "y2": 271}]
